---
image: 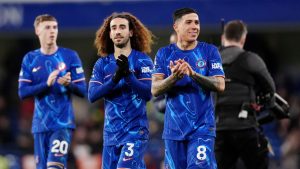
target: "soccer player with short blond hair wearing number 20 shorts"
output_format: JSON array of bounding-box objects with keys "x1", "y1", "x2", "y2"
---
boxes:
[{"x1": 19, "y1": 14, "x2": 86, "y2": 169}]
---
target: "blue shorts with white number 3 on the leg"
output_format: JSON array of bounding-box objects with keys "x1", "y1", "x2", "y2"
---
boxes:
[{"x1": 102, "y1": 140, "x2": 148, "y2": 169}]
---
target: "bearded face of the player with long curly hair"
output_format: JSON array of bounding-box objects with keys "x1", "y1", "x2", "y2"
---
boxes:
[{"x1": 109, "y1": 18, "x2": 132, "y2": 48}]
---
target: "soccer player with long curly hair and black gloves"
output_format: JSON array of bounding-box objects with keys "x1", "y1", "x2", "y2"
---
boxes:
[{"x1": 88, "y1": 12, "x2": 153, "y2": 169}]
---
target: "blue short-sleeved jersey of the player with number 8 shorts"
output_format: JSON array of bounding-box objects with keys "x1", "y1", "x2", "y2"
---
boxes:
[{"x1": 153, "y1": 42, "x2": 224, "y2": 140}]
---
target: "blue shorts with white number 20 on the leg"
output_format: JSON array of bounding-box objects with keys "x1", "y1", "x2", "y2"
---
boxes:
[{"x1": 33, "y1": 129, "x2": 73, "y2": 169}]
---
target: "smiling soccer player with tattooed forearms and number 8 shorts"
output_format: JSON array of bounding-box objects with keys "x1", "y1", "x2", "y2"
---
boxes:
[{"x1": 151, "y1": 8, "x2": 225, "y2": 169}]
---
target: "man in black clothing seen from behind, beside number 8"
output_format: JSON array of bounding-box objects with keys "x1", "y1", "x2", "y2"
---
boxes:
[{"x1": 215, "y1": 20, "x2": 275, "y2": 169}]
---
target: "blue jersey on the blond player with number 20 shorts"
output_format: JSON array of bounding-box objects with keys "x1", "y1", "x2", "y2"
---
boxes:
[{"x1": 19, "y1": 48, "x2": 86, "y2": 133}]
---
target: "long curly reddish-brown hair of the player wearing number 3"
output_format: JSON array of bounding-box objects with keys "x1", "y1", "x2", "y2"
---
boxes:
[{"x1": 94, "y1": 12, "x2": 154, "y2": 57}]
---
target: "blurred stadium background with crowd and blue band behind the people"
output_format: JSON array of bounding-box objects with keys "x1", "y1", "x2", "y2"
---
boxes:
[{"x1": 0, "y1": 0, "x2": 300, "y2": 169}]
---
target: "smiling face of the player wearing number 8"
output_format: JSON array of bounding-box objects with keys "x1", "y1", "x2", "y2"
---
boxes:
[{"x1": 174, "y1": 13, "x2": 200, "y2": 42}]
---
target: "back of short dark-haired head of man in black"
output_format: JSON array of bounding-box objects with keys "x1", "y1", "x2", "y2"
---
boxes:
[{"x1": 224, "y1": 20, "x2": 248, "y2": 42}]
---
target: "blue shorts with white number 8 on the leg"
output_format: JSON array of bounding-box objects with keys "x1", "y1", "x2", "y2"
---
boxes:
[{"x1": 165, "y1": 136, "x2": 217, "y2": 169}]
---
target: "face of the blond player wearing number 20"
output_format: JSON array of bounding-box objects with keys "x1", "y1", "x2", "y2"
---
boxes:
[{"x1": 35, "y1": 21, "x2": 58, "y2": 45}]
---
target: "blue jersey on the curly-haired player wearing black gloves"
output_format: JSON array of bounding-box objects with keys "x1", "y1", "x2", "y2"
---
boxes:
[{"x1": 88, "y1": 50, "x2": 153, "y2": 145}]
